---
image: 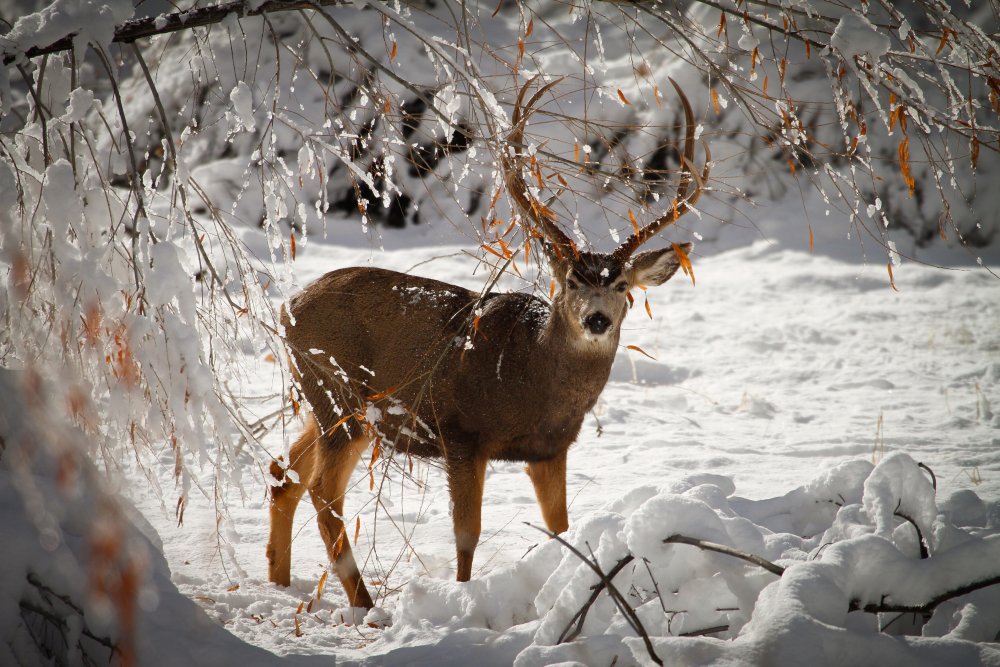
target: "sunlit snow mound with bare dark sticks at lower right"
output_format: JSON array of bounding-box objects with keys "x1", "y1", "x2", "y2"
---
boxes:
[{"x1": 379, "y1": 452, "x2": 1000, "y2": 667}]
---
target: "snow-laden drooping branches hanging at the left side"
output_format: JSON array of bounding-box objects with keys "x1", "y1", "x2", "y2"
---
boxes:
[{"x1": 0, "y1": 43, "x2": 277, "y2": 506}]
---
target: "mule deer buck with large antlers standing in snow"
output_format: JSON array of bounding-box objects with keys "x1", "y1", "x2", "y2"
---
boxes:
[{"x1": 267, "y1": 81, "x2": 710, "y2": 608}]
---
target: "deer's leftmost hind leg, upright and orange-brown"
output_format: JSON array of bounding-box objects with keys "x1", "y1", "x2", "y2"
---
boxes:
[{"x1": 267, "y1": 415, "x2": 320, "y2": 586}]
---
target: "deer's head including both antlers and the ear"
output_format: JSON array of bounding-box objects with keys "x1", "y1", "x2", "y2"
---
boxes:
[{"x1": 500, "y1": 78, "x2": 711, "y2": 351}]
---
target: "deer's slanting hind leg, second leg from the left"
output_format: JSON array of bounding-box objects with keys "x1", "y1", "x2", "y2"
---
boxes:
[{"x1": 309, "y1": 434, "x2": 375, "y2": 609}]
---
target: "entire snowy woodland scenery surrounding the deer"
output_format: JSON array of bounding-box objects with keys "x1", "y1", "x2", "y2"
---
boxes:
[{"x1": 0, "y1": 0, "x2": 1000, "y2": 666}]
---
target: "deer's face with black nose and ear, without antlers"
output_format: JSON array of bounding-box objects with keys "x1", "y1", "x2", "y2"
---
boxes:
[{"x1": 552, "y1": 243, "x2": 691, "y2": 345}]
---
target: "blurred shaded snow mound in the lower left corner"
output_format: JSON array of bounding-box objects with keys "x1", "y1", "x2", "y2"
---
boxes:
[{"x1": 0, "y1": 369, "x2": 312, "y2": 665}]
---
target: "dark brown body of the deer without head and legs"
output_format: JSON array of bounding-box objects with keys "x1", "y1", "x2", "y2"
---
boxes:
[{"x1": 283, "y1": 268, "x2": 615, "y2": 461}]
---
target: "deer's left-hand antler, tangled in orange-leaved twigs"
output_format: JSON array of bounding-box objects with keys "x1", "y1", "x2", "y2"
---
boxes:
[{"x1": 500, "y1": 75, "x2": 577, "y2": 257}]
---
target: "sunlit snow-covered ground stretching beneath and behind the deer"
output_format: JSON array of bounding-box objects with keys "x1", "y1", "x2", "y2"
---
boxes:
[{"x1": 128, "y1": 218, "x2": 1000, "y2": 664}]
